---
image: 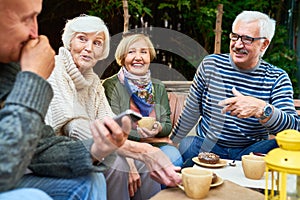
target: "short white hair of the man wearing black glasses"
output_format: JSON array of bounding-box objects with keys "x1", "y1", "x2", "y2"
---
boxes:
[{"x1": 232, "y1": 11, "x2": 276, "y2": 56}]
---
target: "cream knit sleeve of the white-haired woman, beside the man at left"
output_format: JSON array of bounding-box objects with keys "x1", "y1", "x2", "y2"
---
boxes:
[{"x1": 45, "y1": 66, "x2": 92, "y2": 139}]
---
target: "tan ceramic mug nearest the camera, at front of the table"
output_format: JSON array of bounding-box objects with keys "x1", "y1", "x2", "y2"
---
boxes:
[{"x1": 178, "y1": 167, "x2": 212, "y2": 199}]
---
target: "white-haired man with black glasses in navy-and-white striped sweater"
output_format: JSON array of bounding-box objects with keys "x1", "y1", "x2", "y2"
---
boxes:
[{"x1": 171, "y1": 11, "x2": 299, "y2": 166}]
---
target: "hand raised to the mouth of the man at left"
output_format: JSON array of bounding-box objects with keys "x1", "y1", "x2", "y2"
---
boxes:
[{"x1": 20, "y1": 35, "x2": 55, "y2": 79}]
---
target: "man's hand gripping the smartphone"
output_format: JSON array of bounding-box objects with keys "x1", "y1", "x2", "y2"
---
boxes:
[{"x1": 91, "y1": 116, "x2": 131, "y2": 160}]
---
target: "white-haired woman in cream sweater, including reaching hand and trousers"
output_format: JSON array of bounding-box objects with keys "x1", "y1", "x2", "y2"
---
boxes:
[{"x1": 46, "y1": 15, "x2": 181, "y2": 199}]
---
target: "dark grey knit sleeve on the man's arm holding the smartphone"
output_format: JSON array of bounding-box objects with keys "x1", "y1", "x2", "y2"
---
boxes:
[{"x1": 29, "y1": 125, "x2": 113, "y2": 178}]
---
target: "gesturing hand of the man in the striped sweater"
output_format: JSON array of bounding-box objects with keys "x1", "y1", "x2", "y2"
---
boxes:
[{"x1": 219, "y1": 88, "x2": 266, "y2": 118}]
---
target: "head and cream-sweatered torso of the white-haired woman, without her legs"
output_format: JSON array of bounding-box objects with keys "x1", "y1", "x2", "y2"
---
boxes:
[{"x1": 46, "y1": 15, "x2": 114, "y2": 139}]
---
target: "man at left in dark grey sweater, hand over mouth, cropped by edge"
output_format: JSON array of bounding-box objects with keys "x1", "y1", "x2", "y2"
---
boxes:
[{"x1": 0, "y1": 0, "x2": 131, "y2": 200}]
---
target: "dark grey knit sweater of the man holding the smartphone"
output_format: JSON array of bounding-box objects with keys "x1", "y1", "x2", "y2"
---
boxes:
[{"x1": 0, "y1": 63, "x2": 109, "y2": 192}]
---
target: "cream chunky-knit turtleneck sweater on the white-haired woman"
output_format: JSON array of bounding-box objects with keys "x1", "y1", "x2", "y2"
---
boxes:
[{"x1": 45, "y1": 47, "x2": 114, "y2": 139}]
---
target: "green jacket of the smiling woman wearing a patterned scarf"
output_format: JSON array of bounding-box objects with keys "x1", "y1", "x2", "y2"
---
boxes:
[{"x1": 103, "y1": 74, "x2": 172, "y2": 145}]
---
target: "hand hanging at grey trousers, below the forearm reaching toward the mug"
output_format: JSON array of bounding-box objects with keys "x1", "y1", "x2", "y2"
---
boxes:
[{"x1": 126, "y1": 158, "x2": 142, "y2": 197}]
